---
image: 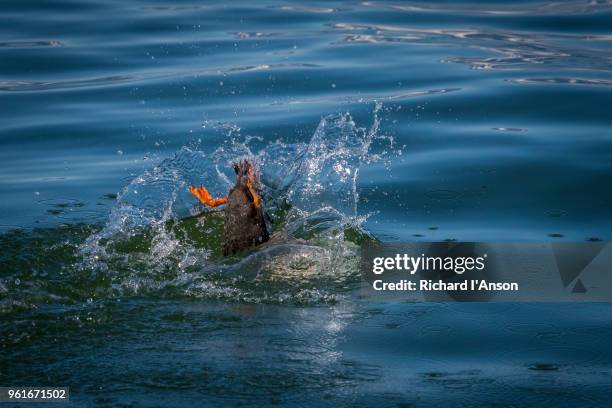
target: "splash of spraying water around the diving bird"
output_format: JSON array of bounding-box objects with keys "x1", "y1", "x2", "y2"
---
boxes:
[{"x1": 79, "y1": 103, "x2": 393, "y2": 303}]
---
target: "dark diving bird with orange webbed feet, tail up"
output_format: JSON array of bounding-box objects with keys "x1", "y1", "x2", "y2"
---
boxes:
[{"x1": 189, "y1": 160, "x2": 270, "y2": 255}]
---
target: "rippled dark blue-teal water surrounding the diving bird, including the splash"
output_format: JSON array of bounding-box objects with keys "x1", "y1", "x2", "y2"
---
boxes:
[{"x1": 0, "y1": 0, "x2": 612, "y2": 407}]
